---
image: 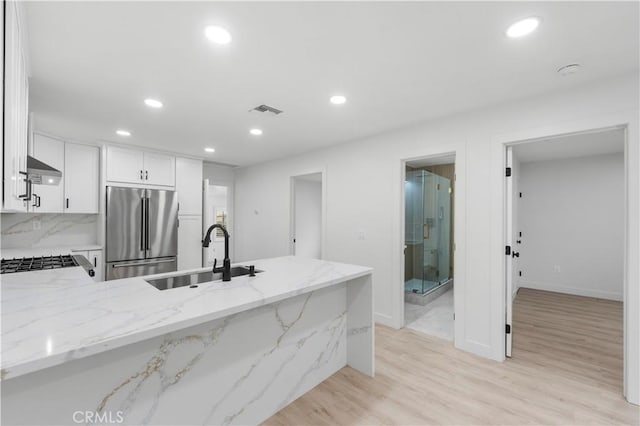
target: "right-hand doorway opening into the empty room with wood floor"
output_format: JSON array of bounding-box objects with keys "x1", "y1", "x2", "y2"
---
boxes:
[{"x1": 505, "y1": 127, "x2": 627, "y2": 391}]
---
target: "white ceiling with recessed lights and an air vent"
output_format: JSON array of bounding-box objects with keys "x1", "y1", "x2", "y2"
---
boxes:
[{"x1": 24, "y1": 2, "x2": 640, "y2": 165}]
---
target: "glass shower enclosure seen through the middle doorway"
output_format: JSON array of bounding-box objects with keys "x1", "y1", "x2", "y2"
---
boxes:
[{"x1": 405, "y1": 170, "x2": 451, "y2": 294}]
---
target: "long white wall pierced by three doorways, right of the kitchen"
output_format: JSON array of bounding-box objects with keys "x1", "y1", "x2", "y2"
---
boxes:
[{"x1": 235, "y1": 70, "x2": 640, "y2": 402}]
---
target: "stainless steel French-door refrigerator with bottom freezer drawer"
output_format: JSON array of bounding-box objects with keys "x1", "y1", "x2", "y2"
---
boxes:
[{"x1": 105, "y1": 186, "x2": 178, "y2": 280}]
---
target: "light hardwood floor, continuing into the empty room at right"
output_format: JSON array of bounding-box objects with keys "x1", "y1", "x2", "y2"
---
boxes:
[{"x1": 265, "y1": 289, "x2": 639, "y2": 425}]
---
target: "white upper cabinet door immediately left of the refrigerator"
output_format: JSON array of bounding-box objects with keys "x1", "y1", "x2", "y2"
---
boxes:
[{"x1": 65, "y1": 143, "x2": 100, "y2": 213}]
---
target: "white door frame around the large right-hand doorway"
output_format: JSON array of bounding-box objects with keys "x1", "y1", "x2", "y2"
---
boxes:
[{"x1": 491, "y1": 111, "x2": 640, "y2": 404}]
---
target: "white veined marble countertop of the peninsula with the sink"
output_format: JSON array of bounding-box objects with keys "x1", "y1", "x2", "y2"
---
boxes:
[{"x1": 0, "y1": 256, "x2": 373, "y2": 380}]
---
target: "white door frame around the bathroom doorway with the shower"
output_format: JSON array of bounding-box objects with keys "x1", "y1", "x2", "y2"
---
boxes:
[{"x1": 393, "y1": 149, "x2": 467, "y2": 349}]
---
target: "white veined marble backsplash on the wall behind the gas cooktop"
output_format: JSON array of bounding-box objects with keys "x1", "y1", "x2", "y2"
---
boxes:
[{"x1": 0, "y1": 213, "x2": 98, "y2": 249}]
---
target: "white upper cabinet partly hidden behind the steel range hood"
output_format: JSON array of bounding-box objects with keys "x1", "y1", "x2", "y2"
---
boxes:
[{"x1": 29, "y1": 133, "x2": 65, "y2": 213}]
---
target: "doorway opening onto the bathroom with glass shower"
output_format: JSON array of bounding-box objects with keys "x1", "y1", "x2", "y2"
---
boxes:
[{"x1": 404, "y1": 155, "x2": 455, "y2": 341}]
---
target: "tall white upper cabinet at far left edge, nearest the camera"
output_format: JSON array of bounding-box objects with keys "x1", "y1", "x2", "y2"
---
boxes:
[{"x1": 2, "y1": 1, "x2": 31, "y2": 212}]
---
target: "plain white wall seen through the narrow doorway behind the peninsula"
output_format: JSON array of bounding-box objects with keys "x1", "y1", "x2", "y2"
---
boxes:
[{"x1": 294, "y1": 178, "x2": 322, "y2": 259}]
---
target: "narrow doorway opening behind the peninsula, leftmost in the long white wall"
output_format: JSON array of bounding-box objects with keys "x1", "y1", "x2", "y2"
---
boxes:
[{"x1": 291, "y1": 172, "x2": 323, "y2": 259}]
